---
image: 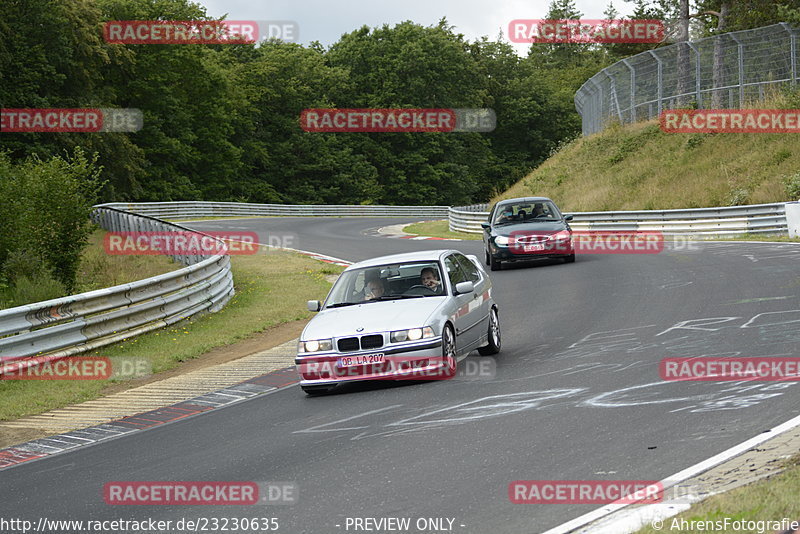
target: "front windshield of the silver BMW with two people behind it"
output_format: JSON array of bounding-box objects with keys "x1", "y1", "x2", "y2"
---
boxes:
[{"x1": 325, "y1": 261, "x2": 444, "y2": 308}]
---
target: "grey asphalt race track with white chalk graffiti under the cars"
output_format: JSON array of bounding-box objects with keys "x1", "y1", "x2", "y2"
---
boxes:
[{"x1": 0, "y1": 218, "x2": 800, "y2": 534}]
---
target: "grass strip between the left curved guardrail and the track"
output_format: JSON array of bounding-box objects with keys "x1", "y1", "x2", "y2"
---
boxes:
[{"x1": 0, "y1": 252, "x2": 343, "y2": 421}]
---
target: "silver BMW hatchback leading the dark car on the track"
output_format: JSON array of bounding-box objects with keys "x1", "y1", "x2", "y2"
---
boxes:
[{"x1": 295, "y1": 250, "x2": 500, "y2": 395}]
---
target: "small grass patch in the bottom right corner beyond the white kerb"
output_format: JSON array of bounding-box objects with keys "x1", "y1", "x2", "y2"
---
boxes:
[{"x1": 637, "y1": 457, "x2": 800, "y2": 534}]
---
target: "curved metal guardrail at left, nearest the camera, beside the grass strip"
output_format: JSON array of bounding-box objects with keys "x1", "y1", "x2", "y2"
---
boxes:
[{"x1": 0, "y1": 206, "x2": 234, "y2": 373}]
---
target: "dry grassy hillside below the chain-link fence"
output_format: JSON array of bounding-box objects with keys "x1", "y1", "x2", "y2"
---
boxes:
[{"x1": 492, "y1": 112, "x2": 800, "y2": 211}]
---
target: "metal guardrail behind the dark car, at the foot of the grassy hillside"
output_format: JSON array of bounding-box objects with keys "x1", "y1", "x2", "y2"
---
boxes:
[{"x1": 448, "y1": 202, "x2": 788, "y2": 237}]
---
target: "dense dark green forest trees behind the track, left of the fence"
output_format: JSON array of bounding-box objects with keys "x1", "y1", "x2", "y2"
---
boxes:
[{"x1": 0, "y1": 0, "x2": 592, "y2": 208}]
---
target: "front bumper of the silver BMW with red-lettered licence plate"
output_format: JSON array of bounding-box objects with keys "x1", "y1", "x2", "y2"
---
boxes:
[{"x1": 295, "y1": 338, "x2": 448, "y2": 386}]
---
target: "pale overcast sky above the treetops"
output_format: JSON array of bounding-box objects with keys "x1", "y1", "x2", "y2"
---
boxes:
[{"x1": 195, "y1": 0, "x2": 633, "y2": 55}]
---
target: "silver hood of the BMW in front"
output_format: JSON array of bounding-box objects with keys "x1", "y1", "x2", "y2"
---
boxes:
[{"x1": 301, "y1": 297, "x2": 447, "y2": 340}]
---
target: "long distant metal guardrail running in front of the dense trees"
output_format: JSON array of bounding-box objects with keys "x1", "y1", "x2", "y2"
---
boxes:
[{"x1": 97, "y1": 201, "x2": 448, "y2": 219}]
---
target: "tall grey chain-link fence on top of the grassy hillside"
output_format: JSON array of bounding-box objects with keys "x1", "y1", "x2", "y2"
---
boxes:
[{"x1": 575, "y1": 22, "x2": 800, "y2": 135}]
